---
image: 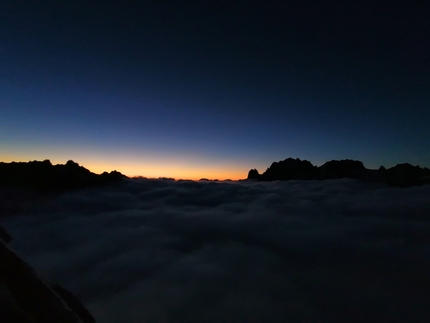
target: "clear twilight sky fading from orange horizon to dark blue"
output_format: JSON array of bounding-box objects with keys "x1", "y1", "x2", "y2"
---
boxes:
[{"x1": 0, "y1": 0, "x2": 430, "y2": 179}]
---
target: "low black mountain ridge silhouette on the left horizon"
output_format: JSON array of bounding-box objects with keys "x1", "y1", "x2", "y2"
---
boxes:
[{"x1": 0, "y1": 160, "x2": 126, "y2": 192}]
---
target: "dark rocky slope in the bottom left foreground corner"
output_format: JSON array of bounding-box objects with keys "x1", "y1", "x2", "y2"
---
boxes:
[{"x1": 0, "y1": 229, "x2": 95, "y2": 323}]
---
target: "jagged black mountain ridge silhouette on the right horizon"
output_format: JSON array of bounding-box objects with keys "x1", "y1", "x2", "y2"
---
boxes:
[{"x1": 248, "y1": 158, "x2": 430, "y2": 187}]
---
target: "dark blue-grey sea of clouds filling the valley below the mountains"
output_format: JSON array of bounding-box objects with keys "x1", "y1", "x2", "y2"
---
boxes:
[{"x1": 1, "y1": 179, "x2": 430, "y2": 323}]
